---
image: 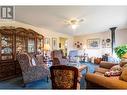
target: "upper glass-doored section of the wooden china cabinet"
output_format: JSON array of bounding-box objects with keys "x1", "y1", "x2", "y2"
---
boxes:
[{"x1": 0, "y1": 27, "x2": 44, "y2": 62}]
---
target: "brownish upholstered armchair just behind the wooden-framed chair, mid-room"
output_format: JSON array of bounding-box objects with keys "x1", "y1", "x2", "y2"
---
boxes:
[{"x1": 51, "y1": 50, "x2": 69, "y2": 65}]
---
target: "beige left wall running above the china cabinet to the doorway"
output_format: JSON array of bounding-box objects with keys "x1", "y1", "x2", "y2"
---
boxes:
[{"x1": 0, "y1": 20, "x2": 73, "y2": 54}]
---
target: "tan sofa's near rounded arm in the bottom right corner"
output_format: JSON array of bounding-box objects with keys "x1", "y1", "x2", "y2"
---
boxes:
[{"x1": 86, "y1": 73, "x2": 127, "y2": 89}]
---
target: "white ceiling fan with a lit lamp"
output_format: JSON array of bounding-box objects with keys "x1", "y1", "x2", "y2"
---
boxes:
[{"x1": 65, "y1": 18, "x2": 84, "y2": 30}]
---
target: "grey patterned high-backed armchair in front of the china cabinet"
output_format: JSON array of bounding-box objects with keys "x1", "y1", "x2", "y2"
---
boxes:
[{"x1": 17, "y1": 53, "x2": 49, "y2": 84}]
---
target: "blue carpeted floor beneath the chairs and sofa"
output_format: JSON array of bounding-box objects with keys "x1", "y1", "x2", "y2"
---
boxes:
[{"x1": 0, "y1": 62, "x2": 98, "y2": 90}]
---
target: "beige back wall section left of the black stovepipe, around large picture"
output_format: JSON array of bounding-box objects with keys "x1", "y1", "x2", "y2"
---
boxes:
[{"x1": 74, "y1": 32, "x2": 111, "y2": 57}]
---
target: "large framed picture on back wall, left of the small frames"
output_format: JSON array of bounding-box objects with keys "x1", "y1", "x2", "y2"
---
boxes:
[{"x1": 87, "y1": 38, "x2": 100, "y2": 49}]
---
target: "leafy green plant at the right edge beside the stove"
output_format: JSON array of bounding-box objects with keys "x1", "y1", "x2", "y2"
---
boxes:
[{"x1": 115, "y1": 44, "x2": 127, "y2": 59}]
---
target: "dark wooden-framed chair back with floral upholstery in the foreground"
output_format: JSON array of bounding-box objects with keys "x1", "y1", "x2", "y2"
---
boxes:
[{"x1": 50, "y1": 65, "x2": 80, "y2": 89}]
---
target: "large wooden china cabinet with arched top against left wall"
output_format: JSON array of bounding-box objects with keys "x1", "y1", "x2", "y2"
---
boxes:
[{"x1": 0, "y1": 26, "x2": 44, "y2": 80}]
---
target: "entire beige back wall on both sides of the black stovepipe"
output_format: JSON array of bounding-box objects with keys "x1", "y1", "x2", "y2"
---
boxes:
[{"x1": 74, "y1": 29, "x2": 127, "y2": 57}]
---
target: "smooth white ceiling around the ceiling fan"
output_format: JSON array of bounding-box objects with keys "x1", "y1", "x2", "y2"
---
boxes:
[{"x1": 15, "y1": 6, "x2": 127, "y2": 35}]
